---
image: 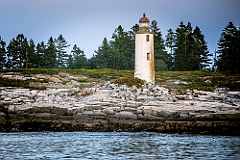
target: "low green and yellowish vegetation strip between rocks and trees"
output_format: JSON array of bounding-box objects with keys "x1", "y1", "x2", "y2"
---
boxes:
[{"x1": 0, "y1": 68, "x2": 240, "y2": 92}]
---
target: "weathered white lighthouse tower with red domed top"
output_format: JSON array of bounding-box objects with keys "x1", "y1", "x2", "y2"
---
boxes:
[{"x1": 134, "y1": 13, "x2": 155, "y2": 83}]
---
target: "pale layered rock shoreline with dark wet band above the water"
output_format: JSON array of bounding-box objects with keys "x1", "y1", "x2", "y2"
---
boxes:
[{"x1": 0, "y1": 73, "x2": 240, "y2": 136}]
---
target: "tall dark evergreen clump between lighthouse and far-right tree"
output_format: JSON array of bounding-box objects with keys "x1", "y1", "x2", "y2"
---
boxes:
[{"x1": 172, "y1": 22, "x2": 211, "y2": 71}]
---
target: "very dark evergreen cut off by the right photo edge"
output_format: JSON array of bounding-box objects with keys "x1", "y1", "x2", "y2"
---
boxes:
[{"x1": 217, "y1": 22, "x2": 240, "y2": 73}]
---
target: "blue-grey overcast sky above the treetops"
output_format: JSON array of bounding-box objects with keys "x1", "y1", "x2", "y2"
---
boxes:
[{"x1": 0, "y1": 0, "x2": 240, "y2": 58}]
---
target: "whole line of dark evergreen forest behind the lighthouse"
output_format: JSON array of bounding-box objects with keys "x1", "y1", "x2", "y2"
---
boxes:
[{"x1": 0, "y1": 21, "x2": 240, "y2": 73}]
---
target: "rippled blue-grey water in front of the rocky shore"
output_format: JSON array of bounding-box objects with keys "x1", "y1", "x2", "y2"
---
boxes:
[{"x1": 0, "y1": 132, "x2": 240, "y2": 160}]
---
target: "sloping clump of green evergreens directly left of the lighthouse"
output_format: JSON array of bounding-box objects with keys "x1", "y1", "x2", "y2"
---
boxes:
[{"x1": 89, "y1": 25, "x2": 135, "y2": 70}]
